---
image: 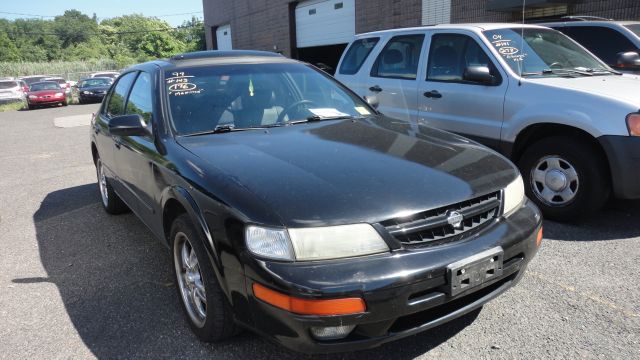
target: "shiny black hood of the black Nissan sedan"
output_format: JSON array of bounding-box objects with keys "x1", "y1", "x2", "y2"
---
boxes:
[{"x1": 178, "y1": 117, "x2": 517, "y2": 227}]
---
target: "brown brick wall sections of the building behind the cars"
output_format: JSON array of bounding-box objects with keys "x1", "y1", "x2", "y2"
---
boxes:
[{"x1": 203, "y1": 0, "x2": 640, "y2": 56}]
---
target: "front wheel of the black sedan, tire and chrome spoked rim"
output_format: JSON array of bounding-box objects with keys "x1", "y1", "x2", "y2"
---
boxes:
[{"x1": 171, "y1": 214, "x2": 237, "y2": 342}]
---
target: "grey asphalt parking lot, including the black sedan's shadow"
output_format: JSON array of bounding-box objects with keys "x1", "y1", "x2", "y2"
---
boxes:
[{"x1": 0, "y1": 105, "x2": 640, "y2": 359}]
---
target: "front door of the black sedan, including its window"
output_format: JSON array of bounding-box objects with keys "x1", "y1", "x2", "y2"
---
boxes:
[{"x1": 114, "y1": 71, "x2": 162, "y2": 233}]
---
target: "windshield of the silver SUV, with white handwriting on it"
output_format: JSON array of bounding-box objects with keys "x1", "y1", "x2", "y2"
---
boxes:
[{"x1": 484, "y1": 28, "x2": 610, "y2": 76}]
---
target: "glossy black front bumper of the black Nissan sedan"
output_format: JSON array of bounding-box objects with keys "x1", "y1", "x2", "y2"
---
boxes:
[{"x1": 245, "y1": 201, "x2": 542, "y2": 353}]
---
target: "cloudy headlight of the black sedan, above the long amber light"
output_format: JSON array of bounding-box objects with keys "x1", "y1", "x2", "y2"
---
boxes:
[{"x1": 246, "y1": 224, "x2": 389, "y2": 261}]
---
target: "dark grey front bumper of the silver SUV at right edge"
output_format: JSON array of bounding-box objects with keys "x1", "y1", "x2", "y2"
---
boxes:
[{"x1": 598, "y1": 135, "x2": 640, "y2": 199}]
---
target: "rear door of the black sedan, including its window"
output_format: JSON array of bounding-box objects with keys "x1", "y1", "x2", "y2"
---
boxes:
[{"x1": 93, "y1": 73, "x2": 136, "y2": 198}]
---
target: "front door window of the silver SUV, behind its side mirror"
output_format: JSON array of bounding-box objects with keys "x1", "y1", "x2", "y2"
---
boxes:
[{"x1": 427, "y1": 34, "x2": 500, "y2": 82}]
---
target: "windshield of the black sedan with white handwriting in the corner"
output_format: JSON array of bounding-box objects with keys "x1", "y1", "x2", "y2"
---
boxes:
[{"x1": 165, "y1": 63, "x2": 371, "y2": 135}]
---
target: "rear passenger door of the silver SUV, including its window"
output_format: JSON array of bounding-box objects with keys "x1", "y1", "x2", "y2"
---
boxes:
[{"x1": 366, "y1": 33, "x2": 425, "y2": 122}]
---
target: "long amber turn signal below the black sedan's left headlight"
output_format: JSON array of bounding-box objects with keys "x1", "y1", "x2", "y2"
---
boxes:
[{"x1": 253, "y1": 283, "x2": 367, "y2": 315}]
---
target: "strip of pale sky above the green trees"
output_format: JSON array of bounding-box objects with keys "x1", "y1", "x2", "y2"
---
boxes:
[{"x1": 0, "y1": 0, "x2": 202, "y2": 26}]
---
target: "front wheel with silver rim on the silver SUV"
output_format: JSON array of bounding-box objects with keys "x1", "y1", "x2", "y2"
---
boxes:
[{"x1": 518, "y1": 136, "x2": 611, "y2": 221}]
